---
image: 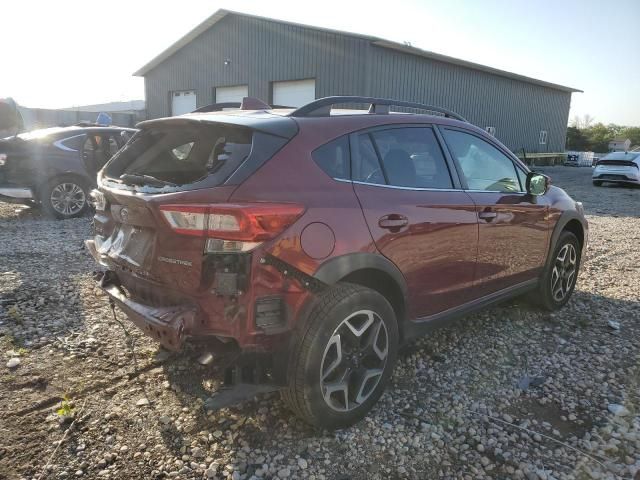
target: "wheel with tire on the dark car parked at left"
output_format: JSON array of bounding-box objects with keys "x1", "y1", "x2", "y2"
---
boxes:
[{"x1": 38, "y1": 175, "x2": 89, "y2": 219}]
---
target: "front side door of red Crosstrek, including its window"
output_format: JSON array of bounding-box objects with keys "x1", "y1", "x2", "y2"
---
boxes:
[{"x1": 442, "y1": 129, "x2": 548, "y2": 296}]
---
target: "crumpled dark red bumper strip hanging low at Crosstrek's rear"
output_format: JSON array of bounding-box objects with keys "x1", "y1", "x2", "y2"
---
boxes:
[{"x1": 99, "y1": 272, "x2": 198, "y2": 351}]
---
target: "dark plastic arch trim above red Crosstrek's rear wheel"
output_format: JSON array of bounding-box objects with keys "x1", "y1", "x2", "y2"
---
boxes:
[{"x1": 314, "y1": 253, "x2": 408, "y2": 341}]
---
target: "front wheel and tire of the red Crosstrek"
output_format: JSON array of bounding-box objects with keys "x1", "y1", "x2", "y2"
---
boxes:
[{"x1": 532, "y1": 230, "x2": 582, "y2": 311}]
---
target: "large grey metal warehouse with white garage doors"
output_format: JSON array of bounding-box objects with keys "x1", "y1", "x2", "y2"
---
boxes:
[{"x1": 134, "y1": 10, "x2": 580, "y2": 152}]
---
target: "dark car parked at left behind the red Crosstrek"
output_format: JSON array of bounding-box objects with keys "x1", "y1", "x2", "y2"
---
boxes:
[{"x1": 0, "y1": 124, "x2": 136, "y2": 218}]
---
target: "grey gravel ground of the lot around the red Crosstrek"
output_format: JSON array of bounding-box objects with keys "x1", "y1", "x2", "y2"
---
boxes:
[{"x1": 0, "y1": 167, "x2": 640, "y2": 480}]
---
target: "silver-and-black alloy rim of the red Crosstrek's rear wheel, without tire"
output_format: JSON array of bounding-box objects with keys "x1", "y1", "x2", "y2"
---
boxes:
[{"x1": 320, "y1": 310, "x2": 389, "y2": 412}]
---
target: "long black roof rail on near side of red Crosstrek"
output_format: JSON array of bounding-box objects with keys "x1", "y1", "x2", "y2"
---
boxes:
[{"x1": 289, "y1": 95, "x2": 467, "y2": 122}]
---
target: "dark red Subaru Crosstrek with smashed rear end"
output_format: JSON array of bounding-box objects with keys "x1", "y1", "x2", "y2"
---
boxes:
[{"x1": 87, "y1": 97, "x2": 587, "y2": 428}]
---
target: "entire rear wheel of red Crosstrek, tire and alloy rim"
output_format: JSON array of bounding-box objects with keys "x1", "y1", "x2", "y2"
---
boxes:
[{"x1": 282, "y1": 283, "x2": 398, "y2": 430}]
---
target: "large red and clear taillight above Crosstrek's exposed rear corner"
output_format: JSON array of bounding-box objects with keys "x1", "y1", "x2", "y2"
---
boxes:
[{"x1": 160, "y1": 203, "x2": 304, "y2": 251}]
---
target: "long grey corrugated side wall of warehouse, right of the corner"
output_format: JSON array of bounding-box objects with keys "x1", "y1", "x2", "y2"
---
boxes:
[{"x1": 370, "y1": 46, "x2": 571, "y2": 152}]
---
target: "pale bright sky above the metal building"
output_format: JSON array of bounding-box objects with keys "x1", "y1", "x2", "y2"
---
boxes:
[{"x1": 0, "y1": 0, "x2": 640, "y2": 126}]
